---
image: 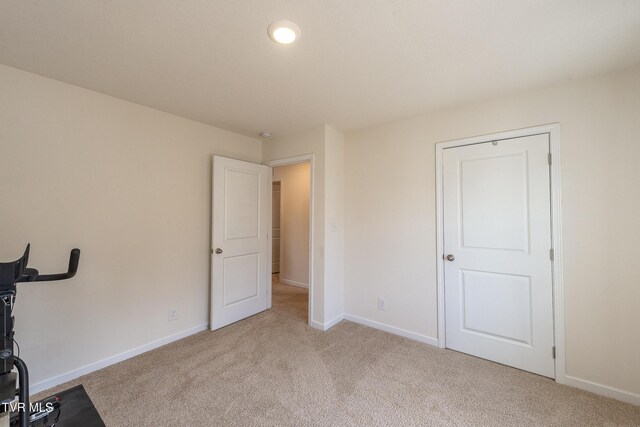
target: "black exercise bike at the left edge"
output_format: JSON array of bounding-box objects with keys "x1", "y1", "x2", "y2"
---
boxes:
[{"x1": 0, "y1": 244, "x2": 80, "y2": 427}]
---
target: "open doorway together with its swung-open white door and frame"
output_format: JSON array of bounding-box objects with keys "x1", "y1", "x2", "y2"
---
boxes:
[{"x1": 209, "y1": 155, "x2": 314, "y2": 330}]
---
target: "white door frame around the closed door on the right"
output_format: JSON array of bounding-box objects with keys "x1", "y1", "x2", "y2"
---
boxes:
[{"x1": 435, "y1": 123, "x2": 566, "y2": 384}]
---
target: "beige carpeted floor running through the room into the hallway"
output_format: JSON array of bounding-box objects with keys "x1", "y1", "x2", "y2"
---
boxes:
[{"x1": 35, "y1": 276, "x2": 640, "y2": 426}]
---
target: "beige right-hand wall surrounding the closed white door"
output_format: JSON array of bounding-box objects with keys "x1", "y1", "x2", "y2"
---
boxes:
[{"x1": 345, "y1": 69, "x2": 640, "y2": 394}]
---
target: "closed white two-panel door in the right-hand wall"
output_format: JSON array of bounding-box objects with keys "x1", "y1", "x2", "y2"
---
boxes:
[{"x1": 443, "y1": 134, "x2": 555, "y2": 378}]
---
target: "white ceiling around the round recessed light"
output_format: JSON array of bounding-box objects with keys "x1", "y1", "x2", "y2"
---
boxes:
[{"x1": 0, "y1": 0, "x2": 640, "y2": 136}]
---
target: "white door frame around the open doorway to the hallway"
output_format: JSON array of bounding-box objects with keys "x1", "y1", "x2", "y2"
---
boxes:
[{"x1": 263, "y1": 154, "x2": 315, "y2": 327}]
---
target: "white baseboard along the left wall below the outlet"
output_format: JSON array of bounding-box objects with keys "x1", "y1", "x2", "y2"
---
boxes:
[{"x1": 29, "y1": 323, "x2": 209, "y2": 394}]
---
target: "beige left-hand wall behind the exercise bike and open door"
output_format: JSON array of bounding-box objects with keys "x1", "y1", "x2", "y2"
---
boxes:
[{"x1": 0, "y1": 66, "x2": 261, "y2": 384}]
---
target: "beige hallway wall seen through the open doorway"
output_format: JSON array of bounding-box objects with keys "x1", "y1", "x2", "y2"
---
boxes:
[{"x1": 273, "y1": 162, "x2": 311, "y2": 286}]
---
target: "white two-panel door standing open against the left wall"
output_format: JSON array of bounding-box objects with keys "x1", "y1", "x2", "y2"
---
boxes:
[{"x1": 210, "y1": 156, "x2": 271, "y2": 330}]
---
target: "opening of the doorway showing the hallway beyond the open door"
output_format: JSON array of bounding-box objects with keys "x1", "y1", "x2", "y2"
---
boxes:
[{"x1": 271, "y1": 161, "x2": 311, "y2": 323}]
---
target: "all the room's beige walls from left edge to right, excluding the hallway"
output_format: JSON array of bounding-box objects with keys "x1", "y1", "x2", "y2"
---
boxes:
[{"x1": 0, "y1": 55, "x2": 640, "y2": 402}]
